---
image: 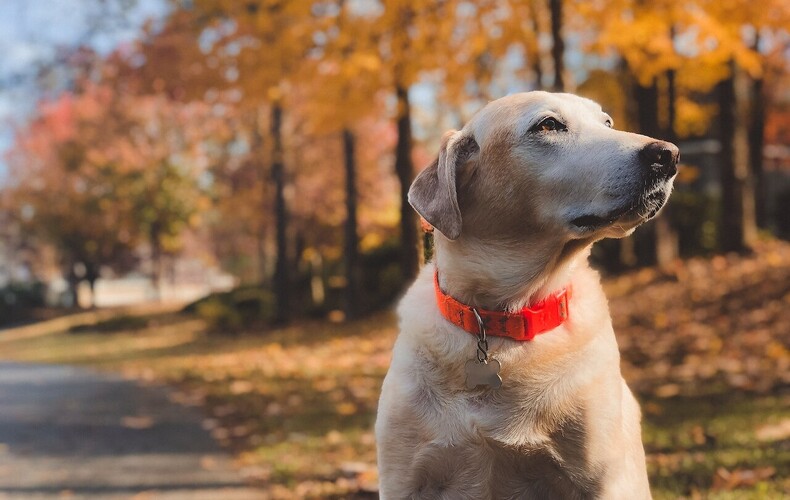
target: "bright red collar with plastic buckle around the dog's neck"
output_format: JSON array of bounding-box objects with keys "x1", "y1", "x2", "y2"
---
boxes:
[{"x1": 433, "y1": 272, "x2": 571, "y2": 340}]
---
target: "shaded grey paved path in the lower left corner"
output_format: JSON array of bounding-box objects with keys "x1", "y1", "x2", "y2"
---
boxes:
[{"x1": 0, "y1": 362, "x2": 262, "y2": 500}]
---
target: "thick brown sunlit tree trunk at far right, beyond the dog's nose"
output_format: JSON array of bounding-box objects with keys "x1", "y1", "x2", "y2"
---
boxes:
[{"x1": 717, "y1": 61, "x2": 756, "y2": 252}]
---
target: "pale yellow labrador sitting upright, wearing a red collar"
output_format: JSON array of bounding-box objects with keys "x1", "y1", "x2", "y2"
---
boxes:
[{"x1": 376, "y1": 92, "x2": 679, "y2": 500}]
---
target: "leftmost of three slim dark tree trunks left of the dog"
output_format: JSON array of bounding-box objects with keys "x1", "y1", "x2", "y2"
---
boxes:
[{"x1": 271, "y1": 103, "x2": 291, "y2": 323}]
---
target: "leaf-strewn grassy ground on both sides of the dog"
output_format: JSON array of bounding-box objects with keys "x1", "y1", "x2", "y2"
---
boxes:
[{"x1": 0, "y1": 241, "x2": 790, "y2": 498}]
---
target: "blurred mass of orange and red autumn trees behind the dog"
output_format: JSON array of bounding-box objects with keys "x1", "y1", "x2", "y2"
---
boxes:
[{"x1": 4, "y1": 0, "x2": 790, "y2": 321}]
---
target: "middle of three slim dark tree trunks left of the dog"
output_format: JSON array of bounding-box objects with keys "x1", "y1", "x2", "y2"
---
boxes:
[{"x1": 343, "y1": 128, "x2": 359, "y2": 319}]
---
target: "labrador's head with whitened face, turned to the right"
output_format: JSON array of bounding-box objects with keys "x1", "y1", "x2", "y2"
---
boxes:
[{"x1": 409, "y1": 92, "x2": 679, "y2": 241}]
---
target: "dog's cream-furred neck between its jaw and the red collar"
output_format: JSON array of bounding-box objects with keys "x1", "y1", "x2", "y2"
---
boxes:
[{"x1": 434, "y1": 234, "x2": 592, "y2": 311}]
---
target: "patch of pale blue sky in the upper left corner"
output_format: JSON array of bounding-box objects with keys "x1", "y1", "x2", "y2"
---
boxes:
[{"x1": 0, "y1": 0, "x2": 167, "y2": 182}]
